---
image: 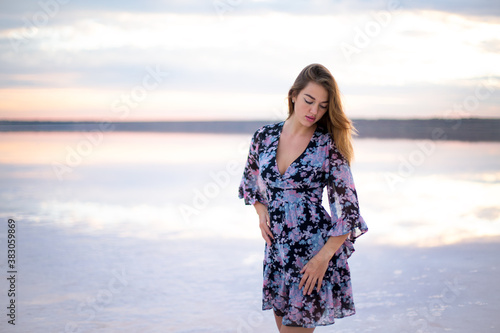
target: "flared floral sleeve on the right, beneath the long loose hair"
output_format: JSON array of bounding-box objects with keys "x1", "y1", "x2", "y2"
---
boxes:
[{"x1": 326, "y1": 140, "x2": 368, "y2": 244}]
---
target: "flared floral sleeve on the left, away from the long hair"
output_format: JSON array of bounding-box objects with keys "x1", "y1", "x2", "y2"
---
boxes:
[{"x1": 238, "y1": 129, "x2": 267, "y2": 206}]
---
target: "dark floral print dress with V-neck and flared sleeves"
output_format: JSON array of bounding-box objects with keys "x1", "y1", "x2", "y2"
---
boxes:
[{"x1": 239, "y1": 122, "x2": 368, "y2": 327}]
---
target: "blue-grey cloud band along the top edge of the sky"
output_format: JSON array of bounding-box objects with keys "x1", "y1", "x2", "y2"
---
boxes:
[{"x1": 0, "y1": 0, "x2": 500, "y2": 28}]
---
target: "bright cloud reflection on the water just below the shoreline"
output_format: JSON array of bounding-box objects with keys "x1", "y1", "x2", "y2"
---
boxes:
[{"x1": 0, "y1": 133, "x2": 500, "y2": 246}]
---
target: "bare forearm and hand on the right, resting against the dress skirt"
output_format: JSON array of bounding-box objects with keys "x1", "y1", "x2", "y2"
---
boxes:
[{"x1": 299, "y1": 234, "x2": 349, "y2": 295}]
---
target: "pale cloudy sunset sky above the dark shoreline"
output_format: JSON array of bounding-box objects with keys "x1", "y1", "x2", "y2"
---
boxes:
[{"x1": 0, "y1": 0, "x2": 500, "y2": 121}]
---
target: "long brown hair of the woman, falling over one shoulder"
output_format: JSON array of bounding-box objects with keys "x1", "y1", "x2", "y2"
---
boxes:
[{"x1": 288, "y1": 64, "x2": 357, "y2": 164}]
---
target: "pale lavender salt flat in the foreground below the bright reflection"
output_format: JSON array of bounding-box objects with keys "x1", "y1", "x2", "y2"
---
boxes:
[{"x1": 0, "y1": 222, "x2": 500, "y2": 332}]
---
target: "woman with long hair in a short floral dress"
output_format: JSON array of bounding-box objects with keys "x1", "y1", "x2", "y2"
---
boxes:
[{"x1": 239, "y1": 64, "x2": 368, "y2": 333}]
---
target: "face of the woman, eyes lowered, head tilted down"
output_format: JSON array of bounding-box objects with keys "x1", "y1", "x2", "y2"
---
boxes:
[{"x1": 292, "y1": 82, "x2": 328, "y2": 127}]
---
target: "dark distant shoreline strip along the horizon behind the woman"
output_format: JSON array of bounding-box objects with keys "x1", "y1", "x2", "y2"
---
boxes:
[{"x1": 0, "y1": 118, "x2": 500, "y2": 141}]
